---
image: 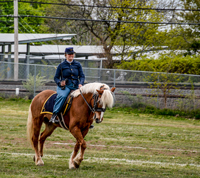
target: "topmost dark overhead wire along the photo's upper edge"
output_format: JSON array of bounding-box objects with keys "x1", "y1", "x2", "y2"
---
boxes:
[{"x1": 0, "y1": 1, "x2": 200, "y2": 11}]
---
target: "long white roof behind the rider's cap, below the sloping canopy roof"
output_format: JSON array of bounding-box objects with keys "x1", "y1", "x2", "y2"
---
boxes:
[{"x1": 0, "y1": 44, "x2": 167, "y2": 60}]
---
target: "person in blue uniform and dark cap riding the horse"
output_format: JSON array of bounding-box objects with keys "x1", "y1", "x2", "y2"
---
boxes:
[{"x1": 49, "y1": 47, "x2": 85, "y2": 123}]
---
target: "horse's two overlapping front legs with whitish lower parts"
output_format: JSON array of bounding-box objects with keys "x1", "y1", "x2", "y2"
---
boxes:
[{"x1": 69, "y1": 127, "x2": 89, "y2": 169}]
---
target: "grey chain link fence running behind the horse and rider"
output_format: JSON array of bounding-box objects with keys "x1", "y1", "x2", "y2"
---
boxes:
[{"x1": 0, "y1": 61, "x2": 200, "y2": 108}]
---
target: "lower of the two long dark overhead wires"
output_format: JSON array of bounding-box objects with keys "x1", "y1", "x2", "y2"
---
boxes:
[{"x1": 0, "y1": 15, "x2": 200, "y2": 25}]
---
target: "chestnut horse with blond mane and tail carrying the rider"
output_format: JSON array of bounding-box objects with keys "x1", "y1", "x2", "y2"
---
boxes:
[{"x1": 27, "y1": 83, "x2": 115, "y2": 169}]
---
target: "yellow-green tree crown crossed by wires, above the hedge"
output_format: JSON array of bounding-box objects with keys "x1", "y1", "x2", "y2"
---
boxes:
[{"x1": 113, "y1": 0, "x2": 165, "y2": 61}]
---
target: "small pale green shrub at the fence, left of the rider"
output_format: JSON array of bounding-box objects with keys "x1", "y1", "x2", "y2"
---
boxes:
[{"x1": 22, "y1": 74, "x2": 45, "y2": 95}]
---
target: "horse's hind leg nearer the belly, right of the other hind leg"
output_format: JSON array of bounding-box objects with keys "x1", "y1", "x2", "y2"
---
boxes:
[{"x1": 40, "y1": 123, "x2": 56, "y2": 157}]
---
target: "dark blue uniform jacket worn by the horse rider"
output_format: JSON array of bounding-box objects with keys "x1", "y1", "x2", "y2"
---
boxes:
[{"x1": 54, "y1": 60, "x2": 85, "y2": 88}]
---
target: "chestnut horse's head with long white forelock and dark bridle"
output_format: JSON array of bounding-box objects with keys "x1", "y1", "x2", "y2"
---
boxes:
[{"x1": 93, "y1": 87, "x2": 115, "y2": 123}]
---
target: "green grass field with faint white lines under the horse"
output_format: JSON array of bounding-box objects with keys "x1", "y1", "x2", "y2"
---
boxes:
[{"x1": 0, "y1": 100, "x2": 200, "y2": 178}]
